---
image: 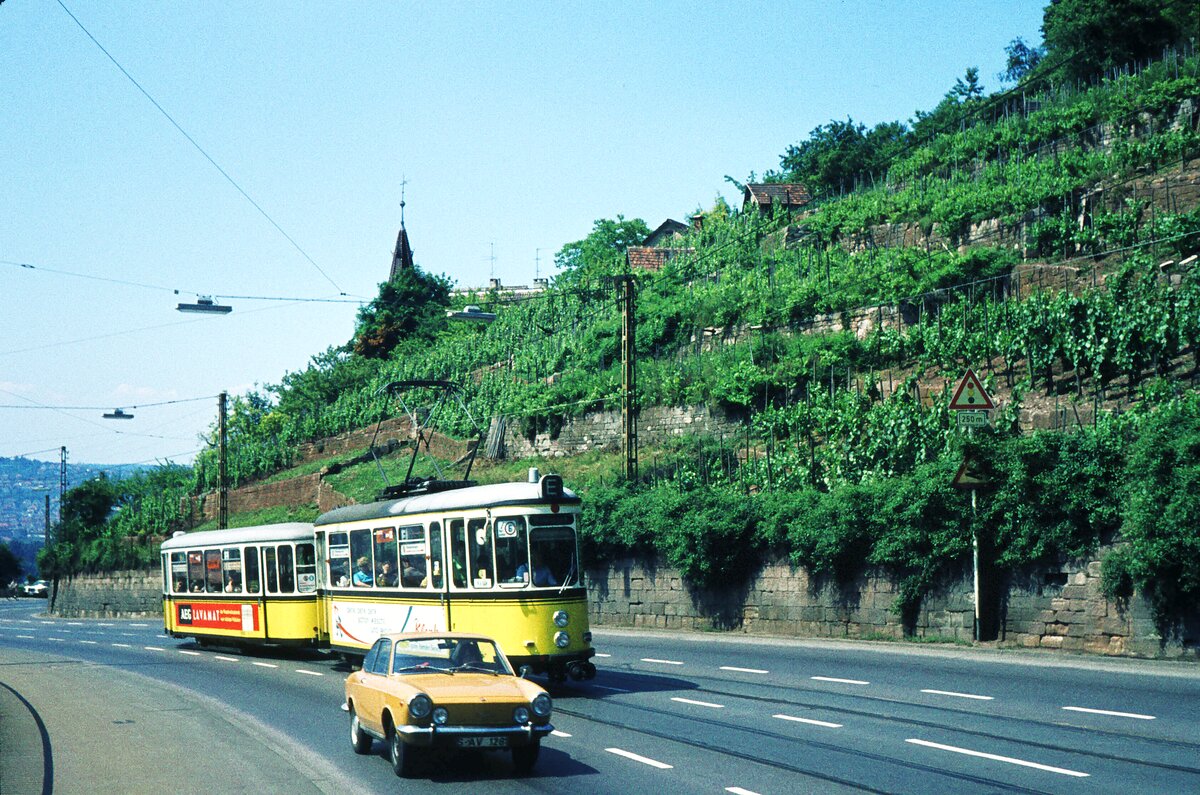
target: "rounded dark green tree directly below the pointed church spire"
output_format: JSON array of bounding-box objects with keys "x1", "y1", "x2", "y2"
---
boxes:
[{"x1": 350, "y1": 267, "x2": 450, "y2": 359}]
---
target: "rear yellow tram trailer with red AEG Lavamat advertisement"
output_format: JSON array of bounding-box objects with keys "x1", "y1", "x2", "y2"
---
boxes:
[{"x1": 162, "y1": 522, "x2": 324, "y2": 646}]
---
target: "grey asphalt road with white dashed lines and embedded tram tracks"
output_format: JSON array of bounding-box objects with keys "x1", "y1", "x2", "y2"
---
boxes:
[{"x1": 0, "y1": 599, "x2": 1200, "y2": 795}]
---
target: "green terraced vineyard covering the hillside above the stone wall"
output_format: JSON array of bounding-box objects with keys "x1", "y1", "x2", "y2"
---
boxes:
[{"x1": 42, "y1": 40, "x2": 1200, "y2": 643}]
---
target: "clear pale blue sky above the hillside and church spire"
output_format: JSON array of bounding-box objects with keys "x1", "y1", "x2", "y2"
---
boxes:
[{"x1": 0, "y1": 0, "x2": 1044, "y2": 464}]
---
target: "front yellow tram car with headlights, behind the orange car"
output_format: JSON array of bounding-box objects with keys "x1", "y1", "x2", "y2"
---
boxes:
[{"x1": 316, "y1": 470, "x2": 595, "y2": 681}]
